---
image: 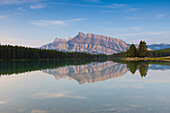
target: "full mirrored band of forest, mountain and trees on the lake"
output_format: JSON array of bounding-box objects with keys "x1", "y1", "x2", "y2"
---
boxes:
[{"x1": 0, "y1": 59, "x2": 170, "y2": 84}]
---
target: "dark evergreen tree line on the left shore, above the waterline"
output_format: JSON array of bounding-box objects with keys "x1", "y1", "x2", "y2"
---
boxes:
[{"x1": 0, "y1": 45, "x2": 107, "y2": 60}]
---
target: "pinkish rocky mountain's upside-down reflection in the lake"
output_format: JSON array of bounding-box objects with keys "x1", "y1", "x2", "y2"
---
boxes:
[{"x1": 43, "y1": 61, "x2": 128, "y2": 84}]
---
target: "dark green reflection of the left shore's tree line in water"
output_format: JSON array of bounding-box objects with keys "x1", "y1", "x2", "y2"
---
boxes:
[{"x1": 0, "y1": 59, "x2": 106, "y2": 76}]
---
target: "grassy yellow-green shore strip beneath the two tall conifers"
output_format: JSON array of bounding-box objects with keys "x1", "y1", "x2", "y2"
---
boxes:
[{"x1": 122, "y1": 56, "x2": 170, "y2": 61}]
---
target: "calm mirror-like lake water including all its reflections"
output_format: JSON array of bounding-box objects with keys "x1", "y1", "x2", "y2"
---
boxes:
[{"x1": 0, "y1": 60, "x2": 170, "y2": 113}]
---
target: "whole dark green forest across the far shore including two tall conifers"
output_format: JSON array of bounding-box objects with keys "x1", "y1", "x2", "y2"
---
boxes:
[{"x1": 0, "y1": 41, "x2": 170, "y2": 61}]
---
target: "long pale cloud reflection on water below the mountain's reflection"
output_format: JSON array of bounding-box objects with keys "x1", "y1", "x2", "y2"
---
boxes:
[{"x1": 33, "y1": 92, "x2": 86, "y2": 99}]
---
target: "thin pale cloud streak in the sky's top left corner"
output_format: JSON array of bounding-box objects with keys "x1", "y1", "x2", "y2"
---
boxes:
[{"x1": 0, "y1": 0, "x2": 44, "y2": 5}]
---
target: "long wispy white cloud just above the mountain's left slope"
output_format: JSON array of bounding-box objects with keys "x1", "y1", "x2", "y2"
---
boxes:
[{"x1": 29, "y1": 18, "x2": 85, "y2": 26}]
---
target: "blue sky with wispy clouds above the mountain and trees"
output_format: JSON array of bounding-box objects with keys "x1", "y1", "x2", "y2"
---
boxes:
[{"x1": 0, "y1": 0, "x2": 170, "y2": 47}]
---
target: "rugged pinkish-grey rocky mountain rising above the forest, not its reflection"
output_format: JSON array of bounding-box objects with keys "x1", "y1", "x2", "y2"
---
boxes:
[{"x1": 41, "y1": 32, "x2": 128, "y2": 55}]
